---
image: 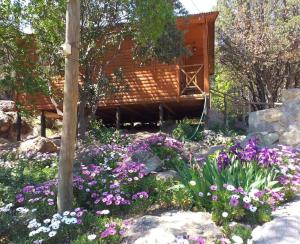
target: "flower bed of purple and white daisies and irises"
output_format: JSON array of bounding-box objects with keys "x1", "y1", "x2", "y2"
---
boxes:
[{"x1": 0, "y1": 134, "x2": 300, "y2": 243}]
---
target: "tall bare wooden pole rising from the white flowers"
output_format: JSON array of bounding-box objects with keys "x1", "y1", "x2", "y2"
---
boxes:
[{"x1": 57, "y1": 0, "x2": 80, "y2": 213}]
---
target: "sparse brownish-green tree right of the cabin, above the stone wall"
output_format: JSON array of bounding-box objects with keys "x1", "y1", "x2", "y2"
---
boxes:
[{"x1": 217, "y1": 0, "x2": 300, "y2": 110}]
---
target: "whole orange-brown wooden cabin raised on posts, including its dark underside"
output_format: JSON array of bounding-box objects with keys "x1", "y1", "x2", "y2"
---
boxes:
[{"x1": 18, "y1": 12, "x2": 218, "y2": 132}]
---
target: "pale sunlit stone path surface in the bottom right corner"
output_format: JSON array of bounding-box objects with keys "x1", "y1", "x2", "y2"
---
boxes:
[{"x1": 252, "y1": 194, "x2": 300, "y2": 244}]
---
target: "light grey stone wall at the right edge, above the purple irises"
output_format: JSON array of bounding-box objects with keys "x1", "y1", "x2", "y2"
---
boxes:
[{"x1": 249, "y1": 88, "x2": 300, "y2": 146}]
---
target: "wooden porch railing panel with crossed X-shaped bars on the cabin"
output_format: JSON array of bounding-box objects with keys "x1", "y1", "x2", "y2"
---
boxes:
[{"x1": 179, "y1": 64, "x2": 204, "y2": 96}]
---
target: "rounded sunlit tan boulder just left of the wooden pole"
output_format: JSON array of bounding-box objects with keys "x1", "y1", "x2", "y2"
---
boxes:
[{"x1": 19, "y1": 136, "x2": 57, "y2": 153}]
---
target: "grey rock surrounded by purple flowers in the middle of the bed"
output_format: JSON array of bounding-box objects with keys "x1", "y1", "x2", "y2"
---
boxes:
[{"x1": 131, "y1": 151, "x2": 164, "y2": 173}]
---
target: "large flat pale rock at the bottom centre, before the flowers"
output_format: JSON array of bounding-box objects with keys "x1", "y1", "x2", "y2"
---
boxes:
[{"x1": 122, "y1": 211, "x2": 222, "y2": 244}]
